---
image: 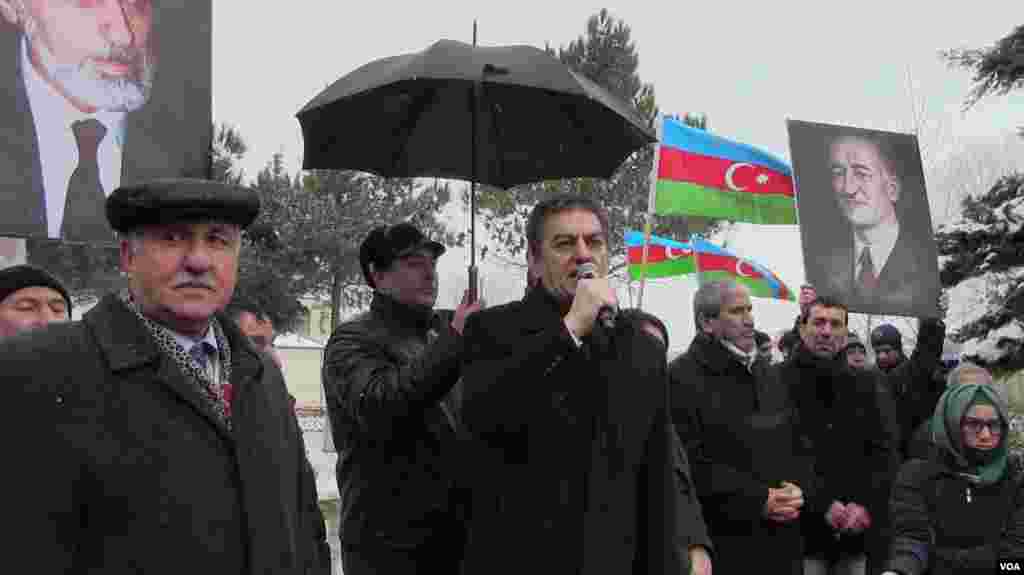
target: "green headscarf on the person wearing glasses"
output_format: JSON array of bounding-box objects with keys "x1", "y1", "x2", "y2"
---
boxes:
[{"x1": 931, "y1": 384, "x2": 1010, "y2": 485}]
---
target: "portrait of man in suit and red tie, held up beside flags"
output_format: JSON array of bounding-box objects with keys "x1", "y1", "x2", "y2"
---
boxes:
[{"x1": 786, "y1": 120, "x2": 939, "y2": 317}]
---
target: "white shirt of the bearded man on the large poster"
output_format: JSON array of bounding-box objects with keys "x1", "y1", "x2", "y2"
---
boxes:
[{"x1": 22, "y1": 35, "x2": 125, "y2": 237}]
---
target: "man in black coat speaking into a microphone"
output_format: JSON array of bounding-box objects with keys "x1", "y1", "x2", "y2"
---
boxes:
[{"x1": 462, "y1": 195, "x2": 711, "y2": 575}]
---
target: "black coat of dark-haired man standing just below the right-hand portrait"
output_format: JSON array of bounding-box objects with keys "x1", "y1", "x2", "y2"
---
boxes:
[{"x1": 779, "y1": 346, "x2": 894, "y2": 556}]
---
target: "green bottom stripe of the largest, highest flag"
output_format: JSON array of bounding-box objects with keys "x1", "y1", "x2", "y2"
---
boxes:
[{"x1": 654, "y1": 180, "x2": 797, "y2": 225}]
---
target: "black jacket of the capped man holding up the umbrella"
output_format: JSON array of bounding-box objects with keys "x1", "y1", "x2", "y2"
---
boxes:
[{"x1": 323, "y1": 294, "x2": 462, "y2": 556}]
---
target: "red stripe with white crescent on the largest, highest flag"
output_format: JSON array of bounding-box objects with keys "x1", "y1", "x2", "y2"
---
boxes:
[{"x1": 657, "y1": 145, "x2": 795, "y2": 197}]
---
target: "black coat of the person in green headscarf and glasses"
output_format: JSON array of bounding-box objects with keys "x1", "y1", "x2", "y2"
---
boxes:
[{"x1": 886, "y1": 453, "x2": 1024, "y2": 575}]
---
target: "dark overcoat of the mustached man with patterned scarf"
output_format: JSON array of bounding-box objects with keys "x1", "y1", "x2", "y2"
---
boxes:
[{"x1": 0, "y1": 296, "x2": 330, "y2": 575}]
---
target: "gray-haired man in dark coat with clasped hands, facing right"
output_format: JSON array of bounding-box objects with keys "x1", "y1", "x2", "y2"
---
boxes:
[{"x1": 669, "y1": 281, "x2": 810, "y2": 575}]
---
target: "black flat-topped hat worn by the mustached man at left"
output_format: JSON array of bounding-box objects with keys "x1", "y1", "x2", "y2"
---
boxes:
[{"x1": 106, "y1": 178, "x2": 259, "y2": 232}]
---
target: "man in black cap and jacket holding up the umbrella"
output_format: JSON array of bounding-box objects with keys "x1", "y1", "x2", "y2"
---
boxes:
[{"x1": 324, "y1": 223, "x2": 480, "y2": 575}]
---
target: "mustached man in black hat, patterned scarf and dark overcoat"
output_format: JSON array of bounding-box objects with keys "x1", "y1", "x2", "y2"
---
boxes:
[{"x1": 0, "y1": 179, "x2": 330, "y2": 575}]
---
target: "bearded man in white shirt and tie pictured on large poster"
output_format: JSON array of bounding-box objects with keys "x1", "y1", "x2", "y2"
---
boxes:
[{"x1": 0, "y1": 0, "x2": 157, "y2": 240}]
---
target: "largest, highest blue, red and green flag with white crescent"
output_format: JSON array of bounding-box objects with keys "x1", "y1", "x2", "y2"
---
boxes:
[{"x1": 651, "y1": 118, "x2": 797, "y2": 224}]
